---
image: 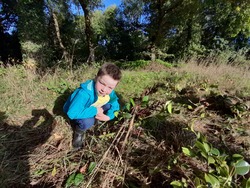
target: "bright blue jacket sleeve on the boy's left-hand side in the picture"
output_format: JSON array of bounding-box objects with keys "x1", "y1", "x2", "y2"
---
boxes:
[{"x1": 67, "y1": 89, "x2": 97, "y2": 119}]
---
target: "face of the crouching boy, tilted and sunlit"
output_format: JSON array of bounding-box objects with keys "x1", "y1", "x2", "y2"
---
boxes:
[{"x1": 95, "y1": 75, "x2": 119, "y2": 96}]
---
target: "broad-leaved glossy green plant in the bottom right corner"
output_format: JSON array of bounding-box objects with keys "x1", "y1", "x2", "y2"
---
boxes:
[{"x1": 171, "y1": 125, "x2": 250, "y2": 188}]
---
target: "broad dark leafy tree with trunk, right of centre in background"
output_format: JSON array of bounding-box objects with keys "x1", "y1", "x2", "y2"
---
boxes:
[{"x1": 144, "y1": 0, "x2": 196, "y2": 61}]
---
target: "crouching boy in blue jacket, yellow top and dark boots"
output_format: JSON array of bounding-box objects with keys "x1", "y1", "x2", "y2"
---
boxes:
[{"x1": 63, "y1": 63, "x2": 121, "y2": 149}]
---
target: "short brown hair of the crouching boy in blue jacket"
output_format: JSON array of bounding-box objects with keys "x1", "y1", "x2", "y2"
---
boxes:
[{"x1": 96, "y1": 63, "x2": 122, "y2": 80}]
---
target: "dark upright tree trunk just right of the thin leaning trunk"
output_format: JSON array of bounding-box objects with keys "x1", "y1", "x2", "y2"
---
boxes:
[{"x1": 79, "y1": 0, "x2": 95, "y2": 64}]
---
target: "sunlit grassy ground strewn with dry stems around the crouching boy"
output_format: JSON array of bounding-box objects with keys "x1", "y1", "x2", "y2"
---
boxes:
[{"x1": 0, "y1": 62, "x2": 250, "y2": 187}]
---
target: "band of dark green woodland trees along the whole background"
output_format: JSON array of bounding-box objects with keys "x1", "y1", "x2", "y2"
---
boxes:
[{"x1": 0, "y1": 0, "x2": 250, "y2": 67}]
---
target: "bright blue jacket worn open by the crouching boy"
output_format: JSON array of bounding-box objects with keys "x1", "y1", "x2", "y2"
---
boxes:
[{"x1": 63, "y1": 80, "x2": 120, "y2": 120}]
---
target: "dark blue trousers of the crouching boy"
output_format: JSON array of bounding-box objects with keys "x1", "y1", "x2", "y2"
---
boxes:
[{"x1": 71, "y1": 104, "x2": 111, "y2": 131}]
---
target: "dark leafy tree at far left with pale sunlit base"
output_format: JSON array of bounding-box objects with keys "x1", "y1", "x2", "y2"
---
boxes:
[{"x1": 16, "y1": 0, "x2": 47, "y2": 64}]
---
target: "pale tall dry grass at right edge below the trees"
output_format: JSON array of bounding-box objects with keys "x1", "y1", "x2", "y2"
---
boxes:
[{"x1": 178, "y1": 60, "x2": 250, "y2": 96}]
